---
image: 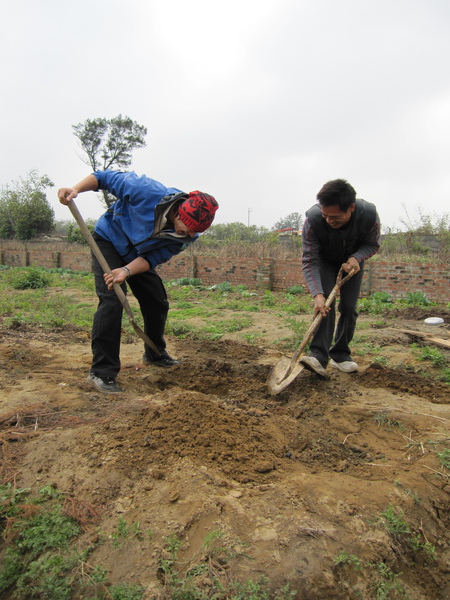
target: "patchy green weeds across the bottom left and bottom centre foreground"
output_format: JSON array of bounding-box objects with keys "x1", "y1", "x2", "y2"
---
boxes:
[{"x1": 0, "y1": 483, "x2": 296, "y2": 600}]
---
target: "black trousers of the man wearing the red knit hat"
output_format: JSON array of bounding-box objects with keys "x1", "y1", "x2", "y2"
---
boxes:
[{"x1": 91, "y1": 236, "x2": 169, "y2": 378}]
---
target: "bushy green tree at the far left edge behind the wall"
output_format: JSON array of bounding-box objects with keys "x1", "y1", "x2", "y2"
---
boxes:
[{"x1": 0, "y1": 170, "x2": 55, "y2": 240}]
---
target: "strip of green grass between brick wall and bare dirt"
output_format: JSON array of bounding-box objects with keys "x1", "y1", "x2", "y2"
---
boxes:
[{"x1": 0, "y1": 267, "x2": 450, "y2": 384}]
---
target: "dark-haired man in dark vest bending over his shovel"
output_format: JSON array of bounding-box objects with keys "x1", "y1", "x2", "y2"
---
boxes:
[{"x1": 300, "y1": 179, "x2": 381, "y2": 377}]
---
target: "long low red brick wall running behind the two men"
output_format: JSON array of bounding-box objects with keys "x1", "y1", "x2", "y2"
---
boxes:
[{"x1": 0, "y1": 240, "x2": 450, "y2": 303}]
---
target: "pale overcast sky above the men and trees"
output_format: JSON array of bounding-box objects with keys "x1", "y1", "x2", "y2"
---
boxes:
[{"x1": 0, "y1": 0, "x2": 450, "y2": 228}]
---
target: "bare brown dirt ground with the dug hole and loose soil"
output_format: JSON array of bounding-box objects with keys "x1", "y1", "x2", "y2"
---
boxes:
[{"x1": 0, "y1": 314, "x2": 450, "y2": 600}]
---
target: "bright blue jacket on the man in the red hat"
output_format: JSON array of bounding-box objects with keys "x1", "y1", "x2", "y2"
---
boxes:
[{"x1": 93, "y1": 171, "x2": 198, "y2": 268}]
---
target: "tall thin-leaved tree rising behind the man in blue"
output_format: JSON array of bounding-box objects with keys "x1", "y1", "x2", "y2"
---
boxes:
[{"x1": 72, "y1": 115, "x2": 147, "y2": 207}]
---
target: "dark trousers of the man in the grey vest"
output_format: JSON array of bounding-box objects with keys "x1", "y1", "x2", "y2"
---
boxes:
[{"x1": 309, "y1": 262, "x2": 363, "y2": 367}]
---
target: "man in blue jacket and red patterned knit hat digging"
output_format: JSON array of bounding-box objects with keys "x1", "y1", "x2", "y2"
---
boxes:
[{"x1": 58, "y1": 171, "x2": 218, "y2": 393}]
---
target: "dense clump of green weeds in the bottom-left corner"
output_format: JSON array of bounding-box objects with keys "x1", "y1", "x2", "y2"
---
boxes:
[{"x1": 0, "y1": 484, "x2": 144, "y2": 600}]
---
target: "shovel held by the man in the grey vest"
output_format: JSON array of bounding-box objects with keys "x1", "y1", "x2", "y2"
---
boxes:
[{"x1": 267, "y1": 267, "x2": 355, "y2": 396}]
